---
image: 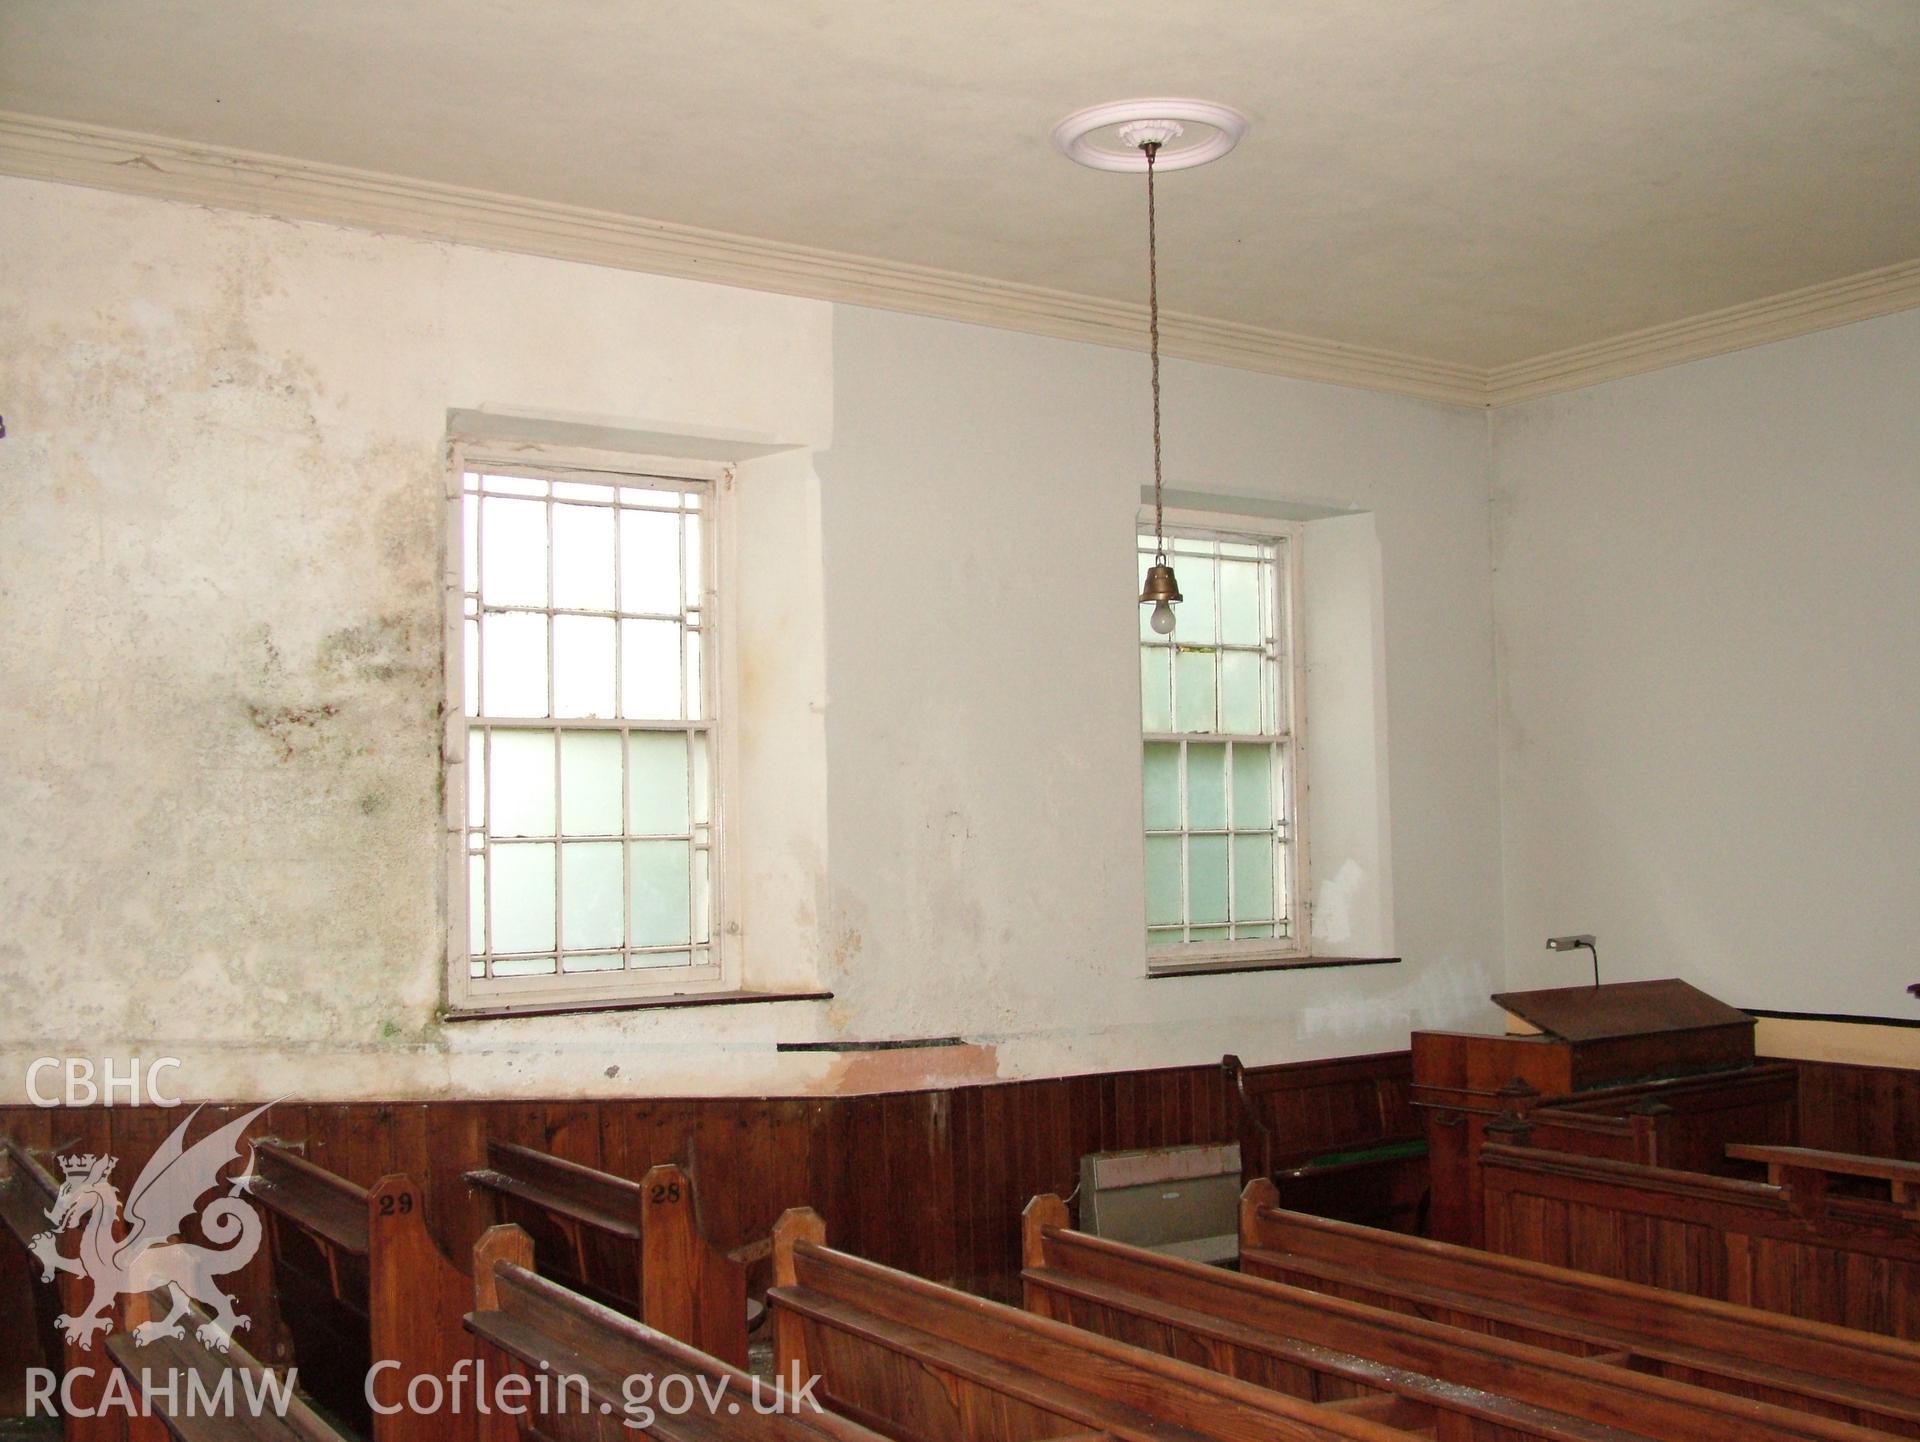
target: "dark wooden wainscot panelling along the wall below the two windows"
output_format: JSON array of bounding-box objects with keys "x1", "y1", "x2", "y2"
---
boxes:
[{"x1": 0, "y1": 1052, "x2": 1407, "y2": 1413}]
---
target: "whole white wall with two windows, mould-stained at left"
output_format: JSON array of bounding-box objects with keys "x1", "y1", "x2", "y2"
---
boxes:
[{"x1": 0, "y1": 180, "x2": 1500, "y2": 1100}]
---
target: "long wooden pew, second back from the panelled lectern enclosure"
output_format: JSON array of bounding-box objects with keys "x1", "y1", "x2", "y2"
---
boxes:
[{"x1": 1021, "y1": 1196, "x2": 1904, "y2": 1442}]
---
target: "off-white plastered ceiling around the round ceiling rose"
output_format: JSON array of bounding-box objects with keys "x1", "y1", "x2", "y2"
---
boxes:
[{"x1": 0, "y1": 0, "x2": 1920, "y2": 367}]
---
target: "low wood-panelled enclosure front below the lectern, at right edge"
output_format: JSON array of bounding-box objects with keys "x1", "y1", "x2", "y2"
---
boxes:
[{"x1": 1480, "y1": 1146, "x2": 1920, "y2": 1338}]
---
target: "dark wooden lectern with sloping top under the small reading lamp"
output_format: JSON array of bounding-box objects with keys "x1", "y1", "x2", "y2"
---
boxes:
[{"x1": 1413, "y1": 979, "x2": 1753, "y2": 1244}]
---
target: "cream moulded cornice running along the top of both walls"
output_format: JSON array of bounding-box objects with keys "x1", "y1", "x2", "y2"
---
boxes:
[{"x1": 0, "y1": 111, "x2": 1920, "y2": 407}]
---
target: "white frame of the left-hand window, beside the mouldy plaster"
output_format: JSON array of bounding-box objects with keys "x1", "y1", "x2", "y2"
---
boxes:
[{"x1": 442, "y1": 440, "x2": 741, "y2": 1016}]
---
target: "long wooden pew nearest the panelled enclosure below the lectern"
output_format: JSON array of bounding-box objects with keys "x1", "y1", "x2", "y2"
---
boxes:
[{"x1": 1240, "y1": 1181, "x2": 1920, "y2": 1436}]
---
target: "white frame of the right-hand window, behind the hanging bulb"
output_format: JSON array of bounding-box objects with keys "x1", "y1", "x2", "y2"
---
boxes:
[{"x1": 1135, "y1": 505, "x2": 1313, "y2": 975}]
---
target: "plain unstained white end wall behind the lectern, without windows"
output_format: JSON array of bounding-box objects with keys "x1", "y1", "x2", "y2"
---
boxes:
[{"x1": 1492, "y1": 311, "x2": 1920, "y2": 1013}]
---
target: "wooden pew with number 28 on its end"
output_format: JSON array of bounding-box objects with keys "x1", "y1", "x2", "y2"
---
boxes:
[{"x1": 467, "y1": 1141, "x2": 747, "y2": 1367}]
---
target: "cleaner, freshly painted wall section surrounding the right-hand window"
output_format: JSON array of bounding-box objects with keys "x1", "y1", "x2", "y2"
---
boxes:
[{"x1": 820, "y1": 309, "x2": 1500, "y2": 1073}]
